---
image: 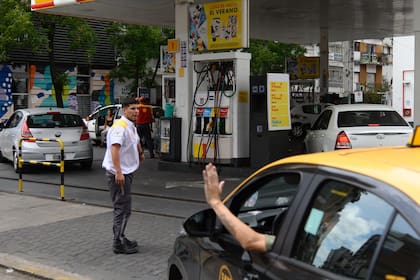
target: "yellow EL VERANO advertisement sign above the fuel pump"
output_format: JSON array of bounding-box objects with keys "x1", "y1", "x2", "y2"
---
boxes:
[{"x1": 189, "y1": 0, "x2": 248, "y2": 52}]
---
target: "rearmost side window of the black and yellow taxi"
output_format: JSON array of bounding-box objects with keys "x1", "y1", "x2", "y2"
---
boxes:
[{"x1": 372, "y1": 215, "x2": 420, "y2": 279}]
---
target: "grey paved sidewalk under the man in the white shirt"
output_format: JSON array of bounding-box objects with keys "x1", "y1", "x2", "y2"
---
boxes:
[{"x1": 0, "y1": 192, "x2": 182, "y2": 280}]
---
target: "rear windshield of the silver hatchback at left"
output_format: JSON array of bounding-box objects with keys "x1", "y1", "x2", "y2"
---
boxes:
[{"x1": 27, "y1": 114, "x2": 83, "y2": 128}]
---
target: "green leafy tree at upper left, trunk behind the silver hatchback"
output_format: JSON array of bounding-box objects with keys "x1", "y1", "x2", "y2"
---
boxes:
[{"x1": 0, "y1": 0, "x2": 96, "y2": 107}]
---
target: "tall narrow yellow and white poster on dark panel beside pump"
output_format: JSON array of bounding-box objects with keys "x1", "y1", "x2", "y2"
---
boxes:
[{"x1": 267, "y1": 74, "x2": 291, "y2": 131}]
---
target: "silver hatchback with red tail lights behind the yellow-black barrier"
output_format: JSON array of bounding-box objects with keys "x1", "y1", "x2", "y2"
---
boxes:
[{"x1": 0, "y1": 108, "x2": 93, "y2": 171}]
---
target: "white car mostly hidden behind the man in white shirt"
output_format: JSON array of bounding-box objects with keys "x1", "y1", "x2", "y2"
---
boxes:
[{"x1": 83, "y1": 104, "x2": 163, "y2": 144}]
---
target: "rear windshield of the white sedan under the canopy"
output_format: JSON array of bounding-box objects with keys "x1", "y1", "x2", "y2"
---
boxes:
[{"x1": 338, "y1": 111, "x2": 408, "y2": 127}]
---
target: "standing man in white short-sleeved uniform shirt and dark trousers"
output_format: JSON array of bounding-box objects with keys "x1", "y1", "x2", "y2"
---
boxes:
[{"x1": 102, "y1": 98, "x2": 144, "y2": 254}]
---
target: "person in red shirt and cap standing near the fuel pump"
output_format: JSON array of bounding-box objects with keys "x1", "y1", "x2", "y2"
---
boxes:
[{"x1": 136, "y1": 97, "x2": 155, "y2": 158}]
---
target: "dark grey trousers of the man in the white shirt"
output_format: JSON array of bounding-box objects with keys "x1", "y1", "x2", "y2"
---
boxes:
[{"x1": 106, "y1": 171, "x2": 134, "y2": 243}]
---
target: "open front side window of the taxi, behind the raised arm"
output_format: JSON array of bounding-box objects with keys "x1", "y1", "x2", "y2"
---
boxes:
[{"x1": 235, "y1": 173, "x2": 300, "y2": 234}]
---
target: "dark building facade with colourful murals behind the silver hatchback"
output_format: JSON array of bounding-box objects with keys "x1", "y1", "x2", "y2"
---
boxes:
[{"x1": 0, "y1": 17, "x2": 116, "y2": 122}]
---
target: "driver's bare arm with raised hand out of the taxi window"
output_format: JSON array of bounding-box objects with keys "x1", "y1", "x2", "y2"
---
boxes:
[{"x1": 203, "y1": 163, "x2": 275, "y2": 252}]
